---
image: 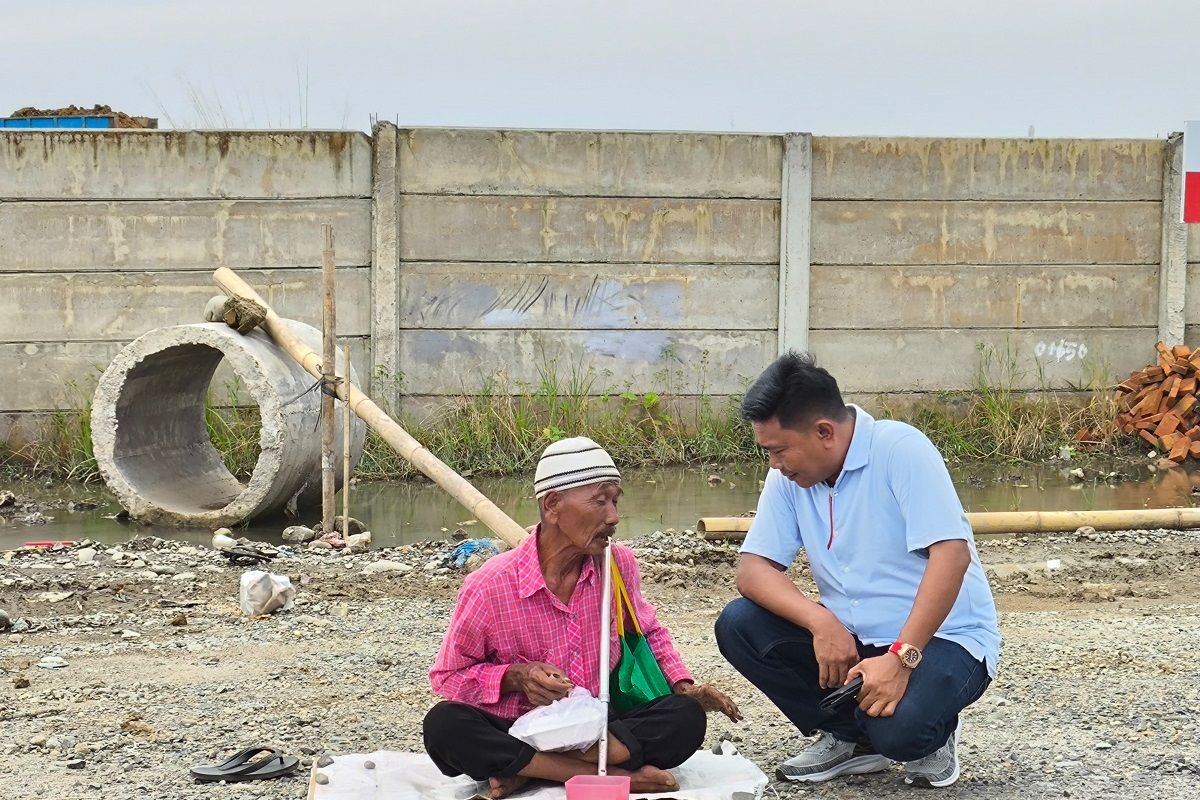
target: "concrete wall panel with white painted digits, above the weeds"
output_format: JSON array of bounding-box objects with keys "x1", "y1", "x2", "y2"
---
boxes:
[{"x1": 811, "y1": 326, "x2": 1157, "y2": 392}]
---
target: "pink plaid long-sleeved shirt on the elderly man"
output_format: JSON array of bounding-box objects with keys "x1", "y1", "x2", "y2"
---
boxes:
[{"x1": 430, "y1": 527, "x2": 691, "y2": 720}]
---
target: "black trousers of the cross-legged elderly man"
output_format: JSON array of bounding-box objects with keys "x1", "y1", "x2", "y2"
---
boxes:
[{"x1": 422, "y1": 694, "x2": 708, "y2": 781}]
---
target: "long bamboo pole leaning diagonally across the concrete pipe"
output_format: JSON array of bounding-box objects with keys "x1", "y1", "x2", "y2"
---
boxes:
[{"x1": 212, "y1": 266, "x2": 528, "y2": 547}]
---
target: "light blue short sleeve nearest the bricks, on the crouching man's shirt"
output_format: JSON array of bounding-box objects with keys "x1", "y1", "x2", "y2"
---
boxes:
[{"x1": 888, "y1": 431, "x2": 973, "y2": 553}]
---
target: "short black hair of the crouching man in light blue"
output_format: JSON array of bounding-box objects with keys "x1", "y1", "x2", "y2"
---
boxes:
[{"x1": 742, "y1": 350, "x2": 850, "y2": 428}]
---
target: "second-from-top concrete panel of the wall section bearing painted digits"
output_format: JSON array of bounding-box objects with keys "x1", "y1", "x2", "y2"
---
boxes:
[{"x1": 812, "y1": 200, "x2": 1162, "y2": 264}]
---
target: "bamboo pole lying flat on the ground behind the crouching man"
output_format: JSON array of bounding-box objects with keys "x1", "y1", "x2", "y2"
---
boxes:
[{"x1": 696, "y1": 509, "x2": 1200, "y2": 540}]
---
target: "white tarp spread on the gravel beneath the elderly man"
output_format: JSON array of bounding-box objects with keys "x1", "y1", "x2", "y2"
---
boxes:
[{"x1": 308, "y1": 745, "x2": 767, "y2": 800}]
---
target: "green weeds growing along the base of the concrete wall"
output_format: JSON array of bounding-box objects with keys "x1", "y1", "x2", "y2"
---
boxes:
[{"x1": 0, "y1": 348, "x2": 1129, "y2": 489}]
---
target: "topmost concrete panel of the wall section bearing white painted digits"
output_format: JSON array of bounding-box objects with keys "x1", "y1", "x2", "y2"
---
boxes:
[{"x1": 812, "y1": 137, "x2": 1164, "y2": 201}]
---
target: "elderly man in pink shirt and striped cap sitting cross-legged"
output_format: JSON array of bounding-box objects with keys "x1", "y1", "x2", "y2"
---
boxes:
[{"x1": 424, "y1": 437, "x2": 740, "y2": 798}]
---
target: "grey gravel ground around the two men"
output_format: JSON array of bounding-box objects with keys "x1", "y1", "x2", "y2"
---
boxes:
[{"x1": 0, "y1": 530, "x2": 1200, "y2": 800}]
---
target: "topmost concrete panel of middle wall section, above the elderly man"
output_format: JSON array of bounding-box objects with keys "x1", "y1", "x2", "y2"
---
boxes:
[{"x1": 400, "y1": 130, "x2": 782, "y2": 198}]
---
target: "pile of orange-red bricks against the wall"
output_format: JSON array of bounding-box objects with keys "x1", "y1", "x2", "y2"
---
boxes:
[{"x1": 1117, "y1": 342, "x2": 1200, "y2": 463}]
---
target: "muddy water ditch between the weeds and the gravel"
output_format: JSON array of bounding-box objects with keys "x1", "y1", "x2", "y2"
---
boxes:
[{"x1": 0, "y1": 462, "x2": 1200, "y2": 549}]
